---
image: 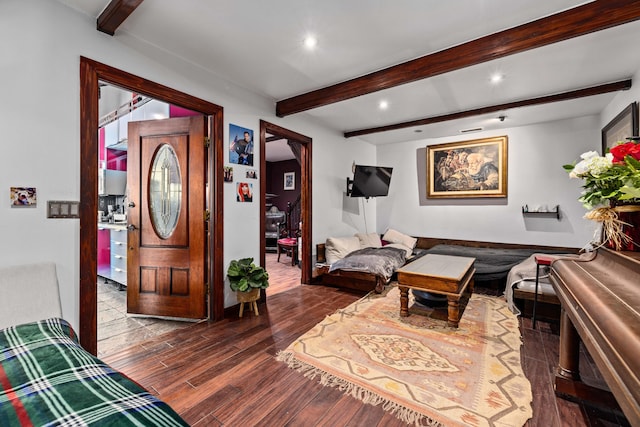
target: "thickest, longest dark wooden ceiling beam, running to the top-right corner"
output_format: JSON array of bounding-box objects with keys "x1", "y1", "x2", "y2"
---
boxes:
[{"x1": 276, "y1": 0, "x2": 640, "y2": 117}]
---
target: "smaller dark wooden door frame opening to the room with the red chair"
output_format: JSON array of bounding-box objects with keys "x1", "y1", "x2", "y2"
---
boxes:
[{"x1": 260, "y1": 120, "x2": 313, "y2": 285}]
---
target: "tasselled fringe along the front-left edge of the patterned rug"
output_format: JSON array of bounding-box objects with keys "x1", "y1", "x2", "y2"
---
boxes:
[{"x1": 276, "y1": 350, "x2": 444, "y2": 427}]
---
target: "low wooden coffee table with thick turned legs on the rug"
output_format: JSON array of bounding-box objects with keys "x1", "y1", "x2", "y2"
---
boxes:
[{"x1": 398, "y1": 254, "x2": 476, "y2": 328}]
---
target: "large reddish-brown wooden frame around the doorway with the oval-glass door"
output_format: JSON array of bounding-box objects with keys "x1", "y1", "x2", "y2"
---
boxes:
[{"x1": 79, "y1": 57, "x2": 224, "y2": 355}]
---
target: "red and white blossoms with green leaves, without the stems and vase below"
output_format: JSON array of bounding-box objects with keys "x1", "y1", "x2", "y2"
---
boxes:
[{"x1": 563, "y1": 141, "x2": 640, "y2": 209}]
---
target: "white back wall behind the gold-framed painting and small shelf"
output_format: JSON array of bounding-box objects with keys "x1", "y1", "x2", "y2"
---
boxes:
[{"x1": 377, "y1": 116, "x2": 600, "y2": 251}]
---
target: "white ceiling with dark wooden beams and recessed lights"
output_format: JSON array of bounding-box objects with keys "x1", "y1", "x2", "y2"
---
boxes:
[{"x1": 58, "y1": 0, "x2": 640, "y2": 144}]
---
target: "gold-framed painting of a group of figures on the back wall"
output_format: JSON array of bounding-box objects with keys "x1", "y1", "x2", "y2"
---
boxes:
[{"x1": 427, "y1": 136, "x2": 508, "y2": 198}]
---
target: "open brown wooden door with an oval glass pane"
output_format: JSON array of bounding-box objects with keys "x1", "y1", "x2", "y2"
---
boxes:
[{"x1": 127, "y1": 116, "x2": 207, "y2": 318}]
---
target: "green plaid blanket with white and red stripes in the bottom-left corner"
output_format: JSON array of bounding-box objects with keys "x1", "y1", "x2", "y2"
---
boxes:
[{"x1": 0, "y1": 319, "x2": 188, "y2": 427}]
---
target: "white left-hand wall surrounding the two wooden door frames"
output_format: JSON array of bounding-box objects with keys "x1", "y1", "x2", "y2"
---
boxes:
[{"x1": 0, "y1": 0, "x2": 375, "y2": 327}]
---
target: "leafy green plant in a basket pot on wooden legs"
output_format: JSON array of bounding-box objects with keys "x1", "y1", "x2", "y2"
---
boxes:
[{"x1": 227, "y1": 258, "x2": 269, "y2": 317}]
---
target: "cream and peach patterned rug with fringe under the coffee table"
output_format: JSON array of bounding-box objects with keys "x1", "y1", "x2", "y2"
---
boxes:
[{"x1": 277, "y1": 287, "x2": 532, "y2": 427}]
